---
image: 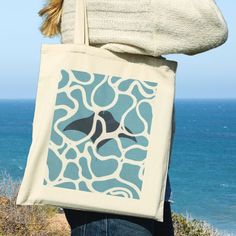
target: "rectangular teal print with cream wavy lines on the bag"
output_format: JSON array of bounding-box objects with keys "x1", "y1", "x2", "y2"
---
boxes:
[{"x1": 43, "y1": 69, "x2": 157, "y2": 199}]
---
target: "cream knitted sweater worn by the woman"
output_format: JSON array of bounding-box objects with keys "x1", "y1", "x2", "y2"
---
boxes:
[{"x1": 61, "y1": 0, "x2": 228, "y2": 56}]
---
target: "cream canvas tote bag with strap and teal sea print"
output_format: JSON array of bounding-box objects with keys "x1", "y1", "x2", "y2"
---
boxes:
[{"x1": 17, "y1": 0, "x2": 177, "y2": 221}]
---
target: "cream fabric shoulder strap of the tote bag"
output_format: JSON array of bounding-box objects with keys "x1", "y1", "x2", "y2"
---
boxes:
[{"x1": 73, "y1": 0, "x2": 89, "y2": 46}]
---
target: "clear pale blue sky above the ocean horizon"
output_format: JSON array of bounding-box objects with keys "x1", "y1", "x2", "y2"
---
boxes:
[{"x1": 0, "y1": 0, "x2": 236, "y2": 99}]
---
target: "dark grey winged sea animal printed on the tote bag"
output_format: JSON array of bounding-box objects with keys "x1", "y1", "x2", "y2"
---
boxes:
[{"x1": 63, "y1": 111, "x2": 137, "y2": 149}]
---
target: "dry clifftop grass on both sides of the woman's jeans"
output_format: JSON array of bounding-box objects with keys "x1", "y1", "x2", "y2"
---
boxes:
[{"x1": 0, "y1": 172, "x2": 232, "y2": 236}]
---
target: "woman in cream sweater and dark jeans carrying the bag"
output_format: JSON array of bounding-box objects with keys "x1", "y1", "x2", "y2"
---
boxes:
[{"x1": 39, "y1": 0, "x2": 228, "y2": 236}]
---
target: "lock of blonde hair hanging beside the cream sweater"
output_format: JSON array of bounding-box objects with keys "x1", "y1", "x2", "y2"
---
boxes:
[{"x1": 38, "y1": 0, "x2": 63, "y2": 37}]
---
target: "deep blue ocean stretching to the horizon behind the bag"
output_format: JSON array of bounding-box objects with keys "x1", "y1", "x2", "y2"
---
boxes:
[{"x1": 0, "y1": 99, "x2": 236, "y2": 235}]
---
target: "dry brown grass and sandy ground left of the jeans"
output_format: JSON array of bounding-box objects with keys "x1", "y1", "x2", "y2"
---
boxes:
[{"x1": 0, "y1": 172, "x2": 69, "y2": 236}]
